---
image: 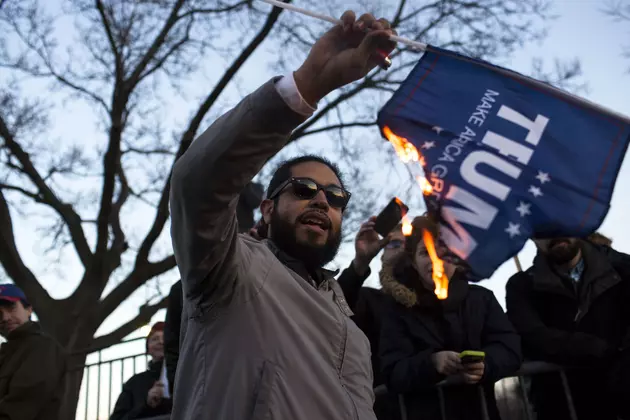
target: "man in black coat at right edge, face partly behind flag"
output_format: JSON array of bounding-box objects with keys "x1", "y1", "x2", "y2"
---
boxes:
[{"x1": 506, "y1": 238, "x2": 630, "y2": 420}]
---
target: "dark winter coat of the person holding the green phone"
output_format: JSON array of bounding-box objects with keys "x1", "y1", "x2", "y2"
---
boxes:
[{"x1": 379, "y1": 267, "x2": 521, "y2": 420}]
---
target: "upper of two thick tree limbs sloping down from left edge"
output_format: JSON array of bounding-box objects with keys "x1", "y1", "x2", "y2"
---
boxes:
[{"x1": 0, "y1": 116, "x2": 92, "y2": 267}]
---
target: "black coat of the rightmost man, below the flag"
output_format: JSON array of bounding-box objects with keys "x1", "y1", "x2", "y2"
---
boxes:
[{"x1": 506, "y1": 242, "x2": 630, "y2": 366}]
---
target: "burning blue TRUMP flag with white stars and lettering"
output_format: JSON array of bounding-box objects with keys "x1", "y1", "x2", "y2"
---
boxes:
[{"x1": 378, "y1": 47, "x2": 630, "y2": 278}]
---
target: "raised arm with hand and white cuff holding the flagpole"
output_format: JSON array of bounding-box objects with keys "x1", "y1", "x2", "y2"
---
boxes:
[{"x1": 170, "y1": 11, "x2": 395, "y2": 302}]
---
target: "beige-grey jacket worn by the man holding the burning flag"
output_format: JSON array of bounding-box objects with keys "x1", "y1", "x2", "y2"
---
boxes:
[{"x1": 171, "y1": 81, "x2": 375, "y2": 420}]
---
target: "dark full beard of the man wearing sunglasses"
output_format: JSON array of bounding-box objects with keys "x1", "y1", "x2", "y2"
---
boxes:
[{"x1": 269, "y1": 211, "x2": 341, "y2": 268}]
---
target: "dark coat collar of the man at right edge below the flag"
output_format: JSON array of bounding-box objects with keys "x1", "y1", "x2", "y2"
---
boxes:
[{"x1": 528, "y1": 241, "x2": 621, "y2": 300}]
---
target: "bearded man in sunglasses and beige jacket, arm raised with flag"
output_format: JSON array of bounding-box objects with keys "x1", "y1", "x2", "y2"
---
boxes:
[{"x1": 170, "y1": 12, "x2": 394, "y2": 420}]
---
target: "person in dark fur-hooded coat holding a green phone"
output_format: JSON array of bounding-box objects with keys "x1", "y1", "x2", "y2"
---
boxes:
[{"x1": 379, "y1": 217, "x2": 521, "y2": 420}]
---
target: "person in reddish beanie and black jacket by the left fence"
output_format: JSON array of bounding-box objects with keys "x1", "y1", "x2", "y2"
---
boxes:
[{"x1": 110, "y1": 322, "x2": 172, "y2": 420}]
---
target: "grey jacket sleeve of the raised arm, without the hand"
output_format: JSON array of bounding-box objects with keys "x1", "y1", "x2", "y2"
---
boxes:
[{"x1": 170, "y1": 76, "x2": 306, "y2": 306}]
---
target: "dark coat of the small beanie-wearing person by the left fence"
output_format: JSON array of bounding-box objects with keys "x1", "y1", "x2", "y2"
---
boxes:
[{"x1": 109, "y1": 361, "x2": 172, "y2": 420}]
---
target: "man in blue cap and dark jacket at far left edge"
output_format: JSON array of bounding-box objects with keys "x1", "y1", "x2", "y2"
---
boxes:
[{"x1": 0, "y1": 284, "x2": 67, "y2": 420}]
